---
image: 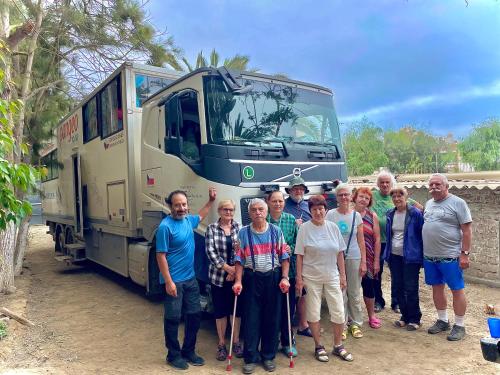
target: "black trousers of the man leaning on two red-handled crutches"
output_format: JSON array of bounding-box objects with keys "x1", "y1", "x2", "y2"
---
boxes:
[{"x1": 243, "y1": 268, "x2": 283, "y2": 363}]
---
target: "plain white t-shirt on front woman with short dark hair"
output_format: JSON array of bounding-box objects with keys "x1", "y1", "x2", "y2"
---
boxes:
[{"x1": 295, "y1": 220, "x2": 346, "y2": 282}]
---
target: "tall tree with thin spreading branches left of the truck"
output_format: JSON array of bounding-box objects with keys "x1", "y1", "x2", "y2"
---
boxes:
[{"x1": 0, "y1": 0, "x2": 179, "y2": 294}]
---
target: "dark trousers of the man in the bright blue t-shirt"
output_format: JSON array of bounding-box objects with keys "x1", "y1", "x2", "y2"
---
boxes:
[{"x1": 163, "y1": 278, "x2": 201, "y2": 360}]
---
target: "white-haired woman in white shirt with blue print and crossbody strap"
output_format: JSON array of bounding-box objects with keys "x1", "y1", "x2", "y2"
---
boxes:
[{"x1": 326, "y1": 184, "x2": 366, "y2": 339}]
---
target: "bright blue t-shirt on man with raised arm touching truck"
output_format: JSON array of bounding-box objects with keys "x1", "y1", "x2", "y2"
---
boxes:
[{"x1": 156, "y1": 215, "x2": 200, "y2": 284}]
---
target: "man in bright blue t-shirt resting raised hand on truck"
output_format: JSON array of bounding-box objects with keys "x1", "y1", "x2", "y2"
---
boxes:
[{"x1": 156, "y1": 188, "x2": 217, "y2": 370}]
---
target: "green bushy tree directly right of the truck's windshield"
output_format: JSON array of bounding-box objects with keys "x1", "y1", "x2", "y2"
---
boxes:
[{"x1": 343, "y1": 118, "x2": 388, "y2": 176}]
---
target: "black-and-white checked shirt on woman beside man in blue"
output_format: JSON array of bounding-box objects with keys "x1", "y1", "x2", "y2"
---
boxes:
[{"x1": 205, "y1": 219, "x2": 240, "y2": 286}]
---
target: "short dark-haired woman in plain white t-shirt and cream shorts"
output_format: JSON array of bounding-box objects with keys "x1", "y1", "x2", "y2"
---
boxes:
[{"x1": 295, "y1": 195, "x2": 353, "y2": 362}]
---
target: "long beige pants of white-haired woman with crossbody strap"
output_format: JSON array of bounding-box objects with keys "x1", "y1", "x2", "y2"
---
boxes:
[{"x1": 342, "y1": 259, "x2": 363, "y2": 326}]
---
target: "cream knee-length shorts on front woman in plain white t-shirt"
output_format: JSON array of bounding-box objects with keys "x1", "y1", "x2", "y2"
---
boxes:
[{"x1": 304, "y1": 278, "x2": 345, "y2": 324}]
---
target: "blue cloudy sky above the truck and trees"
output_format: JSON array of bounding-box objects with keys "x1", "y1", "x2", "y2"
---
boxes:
[{"x1": 146, "y1": 0, "x2": 500, "y2": 137}]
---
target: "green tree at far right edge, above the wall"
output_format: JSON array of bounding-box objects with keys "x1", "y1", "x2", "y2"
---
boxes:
[{"x1": 458, "y1": 118, "x2": 500, "y2": 171}]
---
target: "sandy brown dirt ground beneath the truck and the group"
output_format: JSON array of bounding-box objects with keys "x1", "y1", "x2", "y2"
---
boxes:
[{"x1": 0, "y1": 226, "x2": 500, "y2": 375}]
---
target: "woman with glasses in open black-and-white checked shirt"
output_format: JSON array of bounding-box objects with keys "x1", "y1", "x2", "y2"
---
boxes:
[{"x1": 205, "y1": 199, "x2": 243, "y2": 361}]
